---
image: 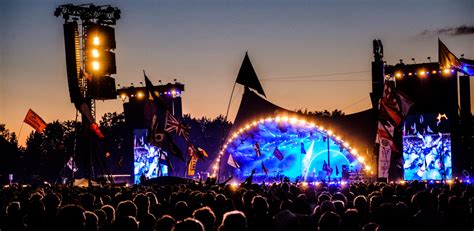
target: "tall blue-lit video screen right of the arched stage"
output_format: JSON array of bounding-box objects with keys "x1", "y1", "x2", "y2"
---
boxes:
[{"x1": 403, "y1": 113, "x2": 452, "y2": 180}]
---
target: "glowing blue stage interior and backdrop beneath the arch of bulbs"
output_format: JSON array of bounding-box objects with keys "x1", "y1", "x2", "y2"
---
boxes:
[{"x1": 223, "y1": 117, "x2": 365, "y2": 180}]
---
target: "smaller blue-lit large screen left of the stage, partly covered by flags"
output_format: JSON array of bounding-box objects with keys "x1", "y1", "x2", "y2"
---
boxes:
[{"x1": 133, "y1": 129, "x2": 168, "y2": 184}]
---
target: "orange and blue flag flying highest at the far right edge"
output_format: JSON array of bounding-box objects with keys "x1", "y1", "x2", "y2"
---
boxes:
[{"x1": 438, "y1": 39, "x2": 474, "y2": 76}]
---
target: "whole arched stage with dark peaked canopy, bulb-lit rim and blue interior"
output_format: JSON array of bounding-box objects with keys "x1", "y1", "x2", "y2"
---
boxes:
[{"x1": 213, "y1": 88, "x2": 375, "y2": 178}]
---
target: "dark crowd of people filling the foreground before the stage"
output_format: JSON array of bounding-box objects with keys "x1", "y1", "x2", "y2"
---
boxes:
[{"x1": 0, "y1": 181, "x2": 474, "y2": 231}]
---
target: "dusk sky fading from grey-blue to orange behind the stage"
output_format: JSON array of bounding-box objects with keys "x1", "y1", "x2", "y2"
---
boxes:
[{"x1": 0, "y1": 0, "x2": 474, "y2": 143}]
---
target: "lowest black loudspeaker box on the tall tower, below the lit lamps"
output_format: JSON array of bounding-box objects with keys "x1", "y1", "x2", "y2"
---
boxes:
[{"x1": 87, "y1": 76, "x2": 117, "y2": 100}]
